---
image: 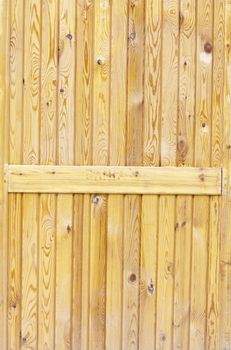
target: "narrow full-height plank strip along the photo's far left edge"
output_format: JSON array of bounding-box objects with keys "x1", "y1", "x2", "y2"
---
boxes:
[{"x1": 0, "y1": 0, "x2": 10, "y2": 350}]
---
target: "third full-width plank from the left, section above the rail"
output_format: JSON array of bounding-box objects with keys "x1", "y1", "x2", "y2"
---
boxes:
[{"x1": 40, "y1": 0, "x2": 58, "y2": 165}]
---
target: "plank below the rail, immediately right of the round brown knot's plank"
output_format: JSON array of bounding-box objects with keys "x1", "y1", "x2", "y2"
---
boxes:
[{"x1": 139, "y1": 196, "x2": 158, "y2": 349}]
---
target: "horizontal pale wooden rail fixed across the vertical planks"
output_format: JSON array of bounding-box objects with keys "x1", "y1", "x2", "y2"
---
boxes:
[{"x1": 5, "y1": 165, "x2": 222, "y2": 195}]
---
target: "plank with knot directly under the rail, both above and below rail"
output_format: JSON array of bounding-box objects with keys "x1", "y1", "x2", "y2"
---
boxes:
[{"x1": 89, "y1": 0, "x2": 111, "y2": 350}]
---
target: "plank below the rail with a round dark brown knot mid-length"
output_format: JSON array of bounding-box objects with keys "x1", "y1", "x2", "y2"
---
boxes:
[{"x1": 122, "y1": 195, "x2": 141, "y2": 350}]
